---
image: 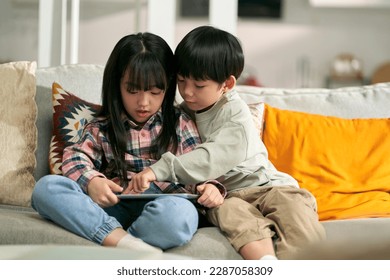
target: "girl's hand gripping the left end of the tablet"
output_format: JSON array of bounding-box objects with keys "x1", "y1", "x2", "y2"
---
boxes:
[{"x1": 88, "y1": 177, "x2": 123, "y2": 208}]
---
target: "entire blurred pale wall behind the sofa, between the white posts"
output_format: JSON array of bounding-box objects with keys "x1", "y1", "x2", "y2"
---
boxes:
[{"x1": 0, "y1": 0, "x2": 390, "y2": 87}]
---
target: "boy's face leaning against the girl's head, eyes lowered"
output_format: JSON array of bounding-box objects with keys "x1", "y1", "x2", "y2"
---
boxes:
[{"x1": 177, "y1": 75, "x2": 224, "y2": 111}]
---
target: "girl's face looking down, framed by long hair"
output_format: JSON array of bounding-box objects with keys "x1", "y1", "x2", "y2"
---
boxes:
[{"x1": 121, "y1": 73, "x2": 165, "y2": 124}]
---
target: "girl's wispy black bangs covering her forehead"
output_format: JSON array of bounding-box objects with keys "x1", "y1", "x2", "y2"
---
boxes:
[{"x1": 127, "y1": 55, "x2": 167, "y2": 90}]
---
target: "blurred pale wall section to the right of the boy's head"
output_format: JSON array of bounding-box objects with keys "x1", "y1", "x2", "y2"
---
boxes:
[{"x1": 232, "y1": 0, "x2": 390, "y2": 87}]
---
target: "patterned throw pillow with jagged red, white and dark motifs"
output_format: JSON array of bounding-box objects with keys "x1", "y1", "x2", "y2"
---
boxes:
[{"x1": 49, "y1": 83, "x2": 101, "y2": 175}]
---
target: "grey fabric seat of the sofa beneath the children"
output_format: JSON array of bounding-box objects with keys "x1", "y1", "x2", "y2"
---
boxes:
[{"x1": 0, "y1": 205, "x2": 390, "y2": 260}]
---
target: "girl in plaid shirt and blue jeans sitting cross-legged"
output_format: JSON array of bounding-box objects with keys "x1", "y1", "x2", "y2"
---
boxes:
[{"x1": 32, "y1": 33, "x2": 213, "y2": 252}]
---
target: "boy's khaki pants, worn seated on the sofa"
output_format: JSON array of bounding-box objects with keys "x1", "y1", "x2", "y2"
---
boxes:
[{"x1": 207, "y1": 186, "x2": 325, "y2": 259}]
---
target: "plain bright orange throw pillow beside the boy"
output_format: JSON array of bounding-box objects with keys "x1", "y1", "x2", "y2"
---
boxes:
[{"x1": 263, "y1": 105, "x2": 390, "y2": 220}]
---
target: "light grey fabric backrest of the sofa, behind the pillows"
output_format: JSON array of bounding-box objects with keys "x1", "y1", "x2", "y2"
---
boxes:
[{"x1": 35, "y1": 64, "x2": 390, "y2": 180}]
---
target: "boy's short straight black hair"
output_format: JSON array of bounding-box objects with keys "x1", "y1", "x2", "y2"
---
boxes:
[{"x1": 175, "y1": 26, "x2": 244, "y2": 84}]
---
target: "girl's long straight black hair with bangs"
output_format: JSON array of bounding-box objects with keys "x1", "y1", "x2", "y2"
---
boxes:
[{"x1": 99, "y1": 32, "x2": 178, "y2": 187}]
